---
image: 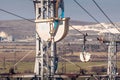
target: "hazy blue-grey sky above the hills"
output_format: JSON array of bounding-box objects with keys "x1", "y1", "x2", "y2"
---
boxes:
[{"x1": 0, "y1": 0, "x2": 120, "y2": 22}]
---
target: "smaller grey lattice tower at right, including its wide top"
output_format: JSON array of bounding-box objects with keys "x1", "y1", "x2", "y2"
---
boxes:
[{"x1": 102, "y1": 34, "x2": 120, "y2": 80}]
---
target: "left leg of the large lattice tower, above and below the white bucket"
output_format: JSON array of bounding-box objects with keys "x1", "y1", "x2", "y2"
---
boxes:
[{"x1": 34, "y1": 0, "x2": 46, "y2": 80}]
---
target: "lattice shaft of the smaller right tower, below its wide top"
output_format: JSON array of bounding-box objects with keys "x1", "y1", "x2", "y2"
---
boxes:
[{"x1": 107, "y1": 41, "x2": 117, "y2": 80}]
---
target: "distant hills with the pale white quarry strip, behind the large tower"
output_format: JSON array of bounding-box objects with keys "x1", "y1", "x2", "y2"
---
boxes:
[{"x1": 0, "y1": 20, "x2": 120, "y2": 41}]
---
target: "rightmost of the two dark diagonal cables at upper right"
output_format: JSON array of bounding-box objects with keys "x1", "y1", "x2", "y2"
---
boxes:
[{"x1": 92, "y1": 0, "x2": 120, "y2": 32}]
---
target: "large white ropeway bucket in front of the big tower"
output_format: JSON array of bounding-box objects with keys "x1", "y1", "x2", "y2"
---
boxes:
[{"x1": 35, "y1": 18, "x2": 69, "y2": 42}]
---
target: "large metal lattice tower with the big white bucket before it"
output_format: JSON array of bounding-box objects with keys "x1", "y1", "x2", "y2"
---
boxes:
[{"x1": 34, "y1": 0, "x2": 69, "y2": 80}]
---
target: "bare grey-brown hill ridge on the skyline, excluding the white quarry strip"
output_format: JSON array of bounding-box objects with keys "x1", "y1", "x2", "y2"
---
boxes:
[{"x1": 0, "y1": 20, "x2": 95, "y2": 39}]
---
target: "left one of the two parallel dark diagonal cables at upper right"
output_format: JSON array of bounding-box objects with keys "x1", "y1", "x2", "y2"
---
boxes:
[{"x1": 73, "y1": 0, "x2": 113, "y2": 34}]
